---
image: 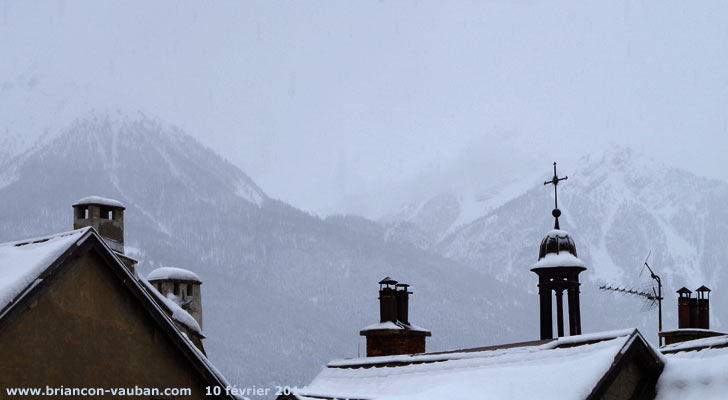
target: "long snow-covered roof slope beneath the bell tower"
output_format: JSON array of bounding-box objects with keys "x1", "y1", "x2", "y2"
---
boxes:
[{"x1": 296, "y1": 329, "x2": 644, "y2": 400}]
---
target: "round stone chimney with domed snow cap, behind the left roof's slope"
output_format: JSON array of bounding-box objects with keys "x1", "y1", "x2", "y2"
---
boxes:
[{"x1": 147, "y1": 267, "x2": 202, "y2": 329}]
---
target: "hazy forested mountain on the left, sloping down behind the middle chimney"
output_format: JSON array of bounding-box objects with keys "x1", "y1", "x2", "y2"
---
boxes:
[{"x1": 0, "y1": 82, "x2": 537, "y2": 396}]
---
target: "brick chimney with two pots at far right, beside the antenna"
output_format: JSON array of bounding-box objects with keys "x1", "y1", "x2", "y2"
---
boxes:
[{"x1": 660, "y1": 285, "x2": 725, "y2": 345}]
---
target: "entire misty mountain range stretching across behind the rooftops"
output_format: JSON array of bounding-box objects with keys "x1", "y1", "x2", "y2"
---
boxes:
[{"x1": 0, "y1": 72, "x2": 728, "y2": 396}]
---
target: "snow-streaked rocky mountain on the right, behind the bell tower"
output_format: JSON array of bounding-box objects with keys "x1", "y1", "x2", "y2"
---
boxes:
[{"x1": 384, "y1": 147, "x2": 728, "y2": 338}]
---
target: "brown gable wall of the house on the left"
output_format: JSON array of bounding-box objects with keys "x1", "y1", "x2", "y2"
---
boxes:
[{"x1": 0, "y1": 252, "x2": 224, "y2": 399}]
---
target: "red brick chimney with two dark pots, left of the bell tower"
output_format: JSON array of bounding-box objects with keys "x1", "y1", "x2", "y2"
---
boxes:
[{"x1": 360, "y1": 277, "x2": 432, "y2": 357}]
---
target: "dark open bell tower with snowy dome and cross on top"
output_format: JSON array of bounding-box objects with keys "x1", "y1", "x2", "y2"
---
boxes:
[{"x1": 531, "y1": 163, "x2": 586, "y2": 340}]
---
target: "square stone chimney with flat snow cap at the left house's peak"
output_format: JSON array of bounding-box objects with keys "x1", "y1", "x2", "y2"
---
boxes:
[{"x1": 73, "y1": 196, "x2": 137, "y2": 275}]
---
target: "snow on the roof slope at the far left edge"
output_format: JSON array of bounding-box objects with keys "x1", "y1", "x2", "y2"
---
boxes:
[{"x1": 0, "y1": 227, "x2": 91, "y2": 310}]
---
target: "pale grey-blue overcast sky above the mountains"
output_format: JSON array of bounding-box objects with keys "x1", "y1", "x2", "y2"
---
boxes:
[{"x1": 0, "y1": 0, "x2": 728, "y2": 214}]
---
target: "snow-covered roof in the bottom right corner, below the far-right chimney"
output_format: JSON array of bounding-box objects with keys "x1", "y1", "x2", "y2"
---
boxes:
[{"x1": 656, "y1": 336, "x2": 728, "y2": 400}]
